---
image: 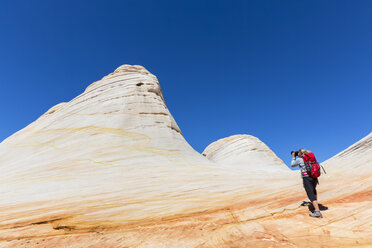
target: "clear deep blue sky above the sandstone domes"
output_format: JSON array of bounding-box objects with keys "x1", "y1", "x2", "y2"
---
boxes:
[{"x1": 0, "y1": 0, "x2": 372, "y2": 168}]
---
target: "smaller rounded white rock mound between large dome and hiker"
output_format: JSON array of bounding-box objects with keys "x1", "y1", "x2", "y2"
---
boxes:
[{"x1": 203, "y1": 135, "x2": 288, "y2": 172}]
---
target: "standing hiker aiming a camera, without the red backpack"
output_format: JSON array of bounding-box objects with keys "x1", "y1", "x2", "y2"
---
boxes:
[{"x1": 291, "y1": 149, "x2": 323, "y2": 218}]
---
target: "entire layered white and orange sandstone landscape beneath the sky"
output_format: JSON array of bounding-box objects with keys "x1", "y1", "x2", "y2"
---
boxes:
[{"x1": 0, "y1": 65, "x2": 372, "y2": 247}]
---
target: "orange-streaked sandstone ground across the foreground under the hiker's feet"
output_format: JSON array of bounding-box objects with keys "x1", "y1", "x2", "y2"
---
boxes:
[{"x1": 0, "y1": 194, "x2": 372, "y2": 247}]
